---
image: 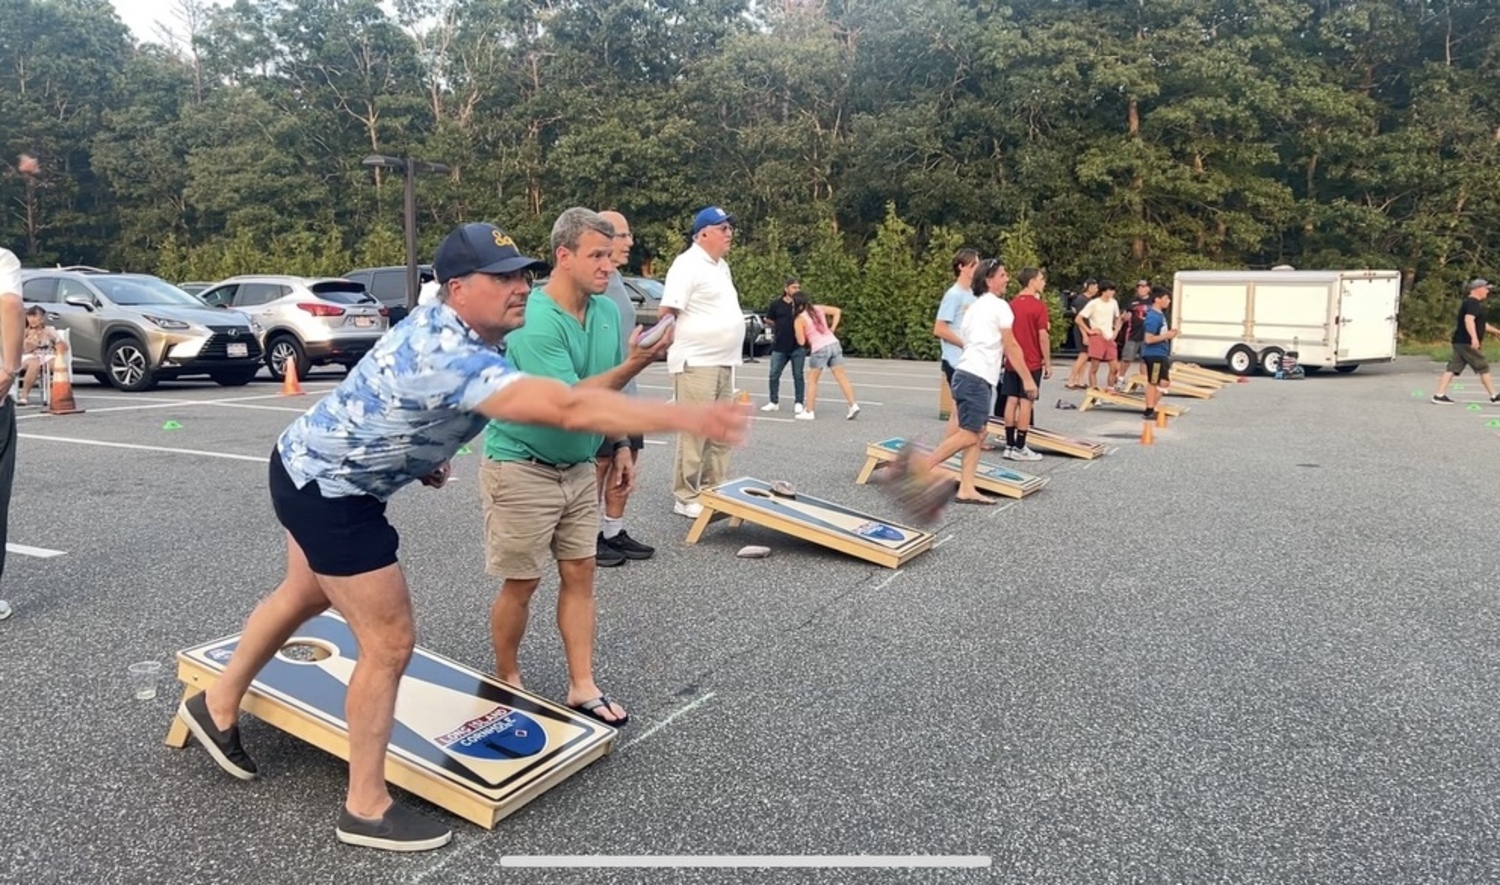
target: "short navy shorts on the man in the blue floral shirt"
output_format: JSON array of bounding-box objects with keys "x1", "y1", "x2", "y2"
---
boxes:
[{"x1": 270, "y1": 447, "x2": 401, "y2": 578}]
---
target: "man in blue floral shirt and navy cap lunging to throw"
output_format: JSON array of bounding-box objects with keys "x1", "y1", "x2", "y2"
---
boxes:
[{"x1": 177, "y1": 224, "x2": 747, "y2": 851}]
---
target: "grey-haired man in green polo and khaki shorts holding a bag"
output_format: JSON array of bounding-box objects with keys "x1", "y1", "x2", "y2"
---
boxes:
[{"x1": 480, "y1": 209, "x2": 671, "y2": 726}]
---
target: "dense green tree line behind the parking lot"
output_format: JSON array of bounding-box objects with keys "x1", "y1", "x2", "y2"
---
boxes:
[{"x1": 0, "y1": 0, "x2": 1500, "y2": 357}]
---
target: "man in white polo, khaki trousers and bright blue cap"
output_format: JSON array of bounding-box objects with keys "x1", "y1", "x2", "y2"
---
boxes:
[{"x1": 660, "y1": 206, "x2": 746, "y2": 519}]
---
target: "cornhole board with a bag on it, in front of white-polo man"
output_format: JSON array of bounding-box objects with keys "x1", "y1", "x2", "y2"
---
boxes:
[{"x1": 687, "y1": 477, "x2": 933, "y2": 569}]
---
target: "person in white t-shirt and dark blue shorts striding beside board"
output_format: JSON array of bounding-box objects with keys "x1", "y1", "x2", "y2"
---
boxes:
[{"x1": 897, "y1": 258, "x2": 1037, "y2": 504}]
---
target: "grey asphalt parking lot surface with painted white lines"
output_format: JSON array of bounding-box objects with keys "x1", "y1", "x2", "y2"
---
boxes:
[{"x1": 0, "y1": 359, "x2": 1500, "y2": 884}]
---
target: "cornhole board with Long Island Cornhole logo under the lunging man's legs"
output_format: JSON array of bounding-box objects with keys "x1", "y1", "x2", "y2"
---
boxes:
[{"x1": 167, "y1": 612, "x2": 618, "y2": 828}]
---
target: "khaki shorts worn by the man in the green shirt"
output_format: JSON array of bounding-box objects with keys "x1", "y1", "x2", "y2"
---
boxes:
[{"x1": 479, "y1": 458, "x2": 599, "y2": 581}]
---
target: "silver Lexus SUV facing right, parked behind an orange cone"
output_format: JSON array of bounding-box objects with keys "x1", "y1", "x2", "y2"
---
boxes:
[{"x1": 21, "y1": 267, "x2": 261, "y2": 392}]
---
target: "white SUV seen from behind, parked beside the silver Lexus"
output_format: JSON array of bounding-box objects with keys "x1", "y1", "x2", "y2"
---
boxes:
[{"x1": 198, "y1": 276, "x2": 390, "y2": 381}]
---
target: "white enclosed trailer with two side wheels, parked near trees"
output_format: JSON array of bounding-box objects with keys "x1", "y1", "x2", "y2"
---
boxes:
[{"x1": 1170, "y1": 270, "x2": 1401, "y2": 375}]
